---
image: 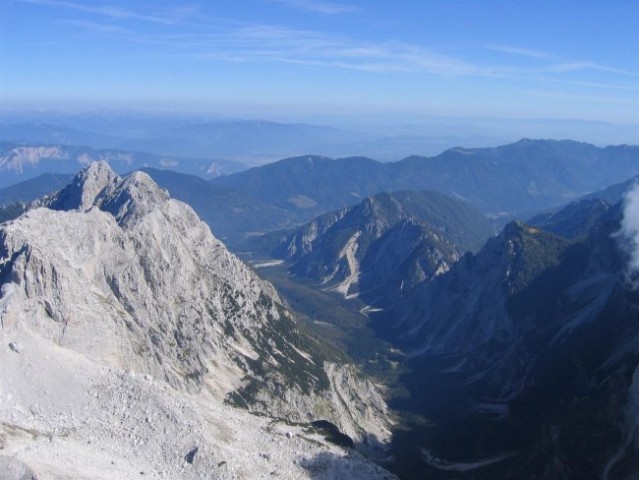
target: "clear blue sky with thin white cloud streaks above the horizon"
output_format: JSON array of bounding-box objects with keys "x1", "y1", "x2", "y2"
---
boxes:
[{"x1": 0, "y1": 0, "x2": 639, "y2": 123}]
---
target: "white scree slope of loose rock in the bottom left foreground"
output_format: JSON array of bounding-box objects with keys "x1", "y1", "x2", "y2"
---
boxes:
[{"x1": 0, "y1": 329, "x2": 394, "y2": 480}]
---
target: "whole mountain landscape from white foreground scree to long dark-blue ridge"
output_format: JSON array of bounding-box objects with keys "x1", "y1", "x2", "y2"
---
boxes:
[{"x1": 0, "y1": 140, "x2": 639, "y2": 480}]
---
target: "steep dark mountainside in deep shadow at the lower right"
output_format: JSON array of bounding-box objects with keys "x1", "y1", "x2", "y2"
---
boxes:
[{"x1": 377, "y1": 192, "x2": 639, "y2": 480}]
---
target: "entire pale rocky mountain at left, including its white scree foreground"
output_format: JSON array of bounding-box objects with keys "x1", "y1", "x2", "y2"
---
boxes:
[{"x1": 0, "y1": 162, "x2": 392, "y2": 479}]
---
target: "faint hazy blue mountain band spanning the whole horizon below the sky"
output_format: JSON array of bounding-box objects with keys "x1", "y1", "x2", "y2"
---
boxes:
[{"x1": 0, "y1": 111, "x2": 639, "y2": 161}]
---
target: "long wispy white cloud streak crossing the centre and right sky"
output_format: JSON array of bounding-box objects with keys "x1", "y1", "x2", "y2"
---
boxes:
[{"x1": 165, "y1": 25, "x2": 638, "y2": 77}]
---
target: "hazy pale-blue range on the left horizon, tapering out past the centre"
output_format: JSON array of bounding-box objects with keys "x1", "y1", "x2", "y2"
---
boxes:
[{"x1": 0, "y1": 118, "x2": 374, "y2": 165}]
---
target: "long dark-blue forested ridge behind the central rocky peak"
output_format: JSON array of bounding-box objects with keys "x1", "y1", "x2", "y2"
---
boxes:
[{"x1": 213, "y1": 139, "x2": 639, "y2": 219}]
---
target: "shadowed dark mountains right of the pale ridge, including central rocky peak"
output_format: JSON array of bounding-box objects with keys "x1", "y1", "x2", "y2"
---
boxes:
[{"x1": 244, "y1": 172, "x2": 639, "y2": 480}]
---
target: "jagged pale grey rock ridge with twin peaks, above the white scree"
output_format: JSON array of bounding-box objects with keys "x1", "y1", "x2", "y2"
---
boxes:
[{"x1": 0, "y1": 162, "x2": 388, "y2": 444}]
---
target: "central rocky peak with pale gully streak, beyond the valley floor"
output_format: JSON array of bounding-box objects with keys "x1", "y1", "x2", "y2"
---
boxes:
[{"x1": 261, "y1": 192, "x2": 493, "y2": 307}]
